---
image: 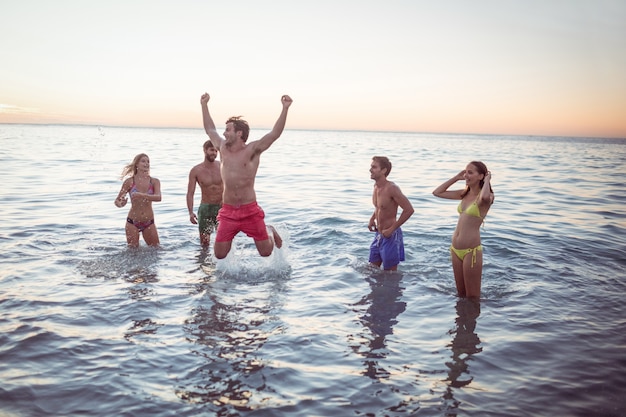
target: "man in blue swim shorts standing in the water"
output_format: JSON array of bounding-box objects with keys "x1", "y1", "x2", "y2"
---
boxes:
[{"x1": 368, "y1": 156, "x2": 415, "y2": 271}]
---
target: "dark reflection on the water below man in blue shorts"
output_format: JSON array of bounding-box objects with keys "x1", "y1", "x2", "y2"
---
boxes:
[{"x1": 351, "y1": 272, "x2": 406, "y2": 379}]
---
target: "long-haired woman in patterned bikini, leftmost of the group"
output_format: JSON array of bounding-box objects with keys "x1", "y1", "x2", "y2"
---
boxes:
[{"x1": 115, "y1": 153, "x2": 161, "y2": 247}]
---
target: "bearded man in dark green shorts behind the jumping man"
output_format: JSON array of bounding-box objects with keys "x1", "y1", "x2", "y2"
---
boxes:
[{"x1": 187, "y1": 140, "x2": 224, "y2": 247}]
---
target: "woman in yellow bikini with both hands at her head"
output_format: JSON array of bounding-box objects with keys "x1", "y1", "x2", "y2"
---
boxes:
[{"x1": 433, "y1": 161, "x2": 494, "y2": 297}]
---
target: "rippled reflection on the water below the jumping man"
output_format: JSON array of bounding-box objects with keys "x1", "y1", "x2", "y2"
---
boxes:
[{"x1": 176, "y1": 252, "x2": 285, "y2": 416}]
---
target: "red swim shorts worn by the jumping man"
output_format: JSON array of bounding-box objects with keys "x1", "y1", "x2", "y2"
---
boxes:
[{"x1": 215, "y1": 201, "x2": 269, "y2": 242}]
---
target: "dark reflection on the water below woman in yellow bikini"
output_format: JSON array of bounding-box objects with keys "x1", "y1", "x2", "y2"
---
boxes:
[{"x1": 443, "y1": 298, "x2": 483, "y2": 416}]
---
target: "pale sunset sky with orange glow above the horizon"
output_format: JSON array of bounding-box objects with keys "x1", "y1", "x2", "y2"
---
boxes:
[{"x1": 0, "y1": 0, "x2": 626, "y2": 138}]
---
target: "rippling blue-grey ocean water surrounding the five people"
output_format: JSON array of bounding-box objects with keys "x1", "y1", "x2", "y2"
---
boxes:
[{"x1": 0, "y1": 125, "x2": 626, "y2": 417}]
